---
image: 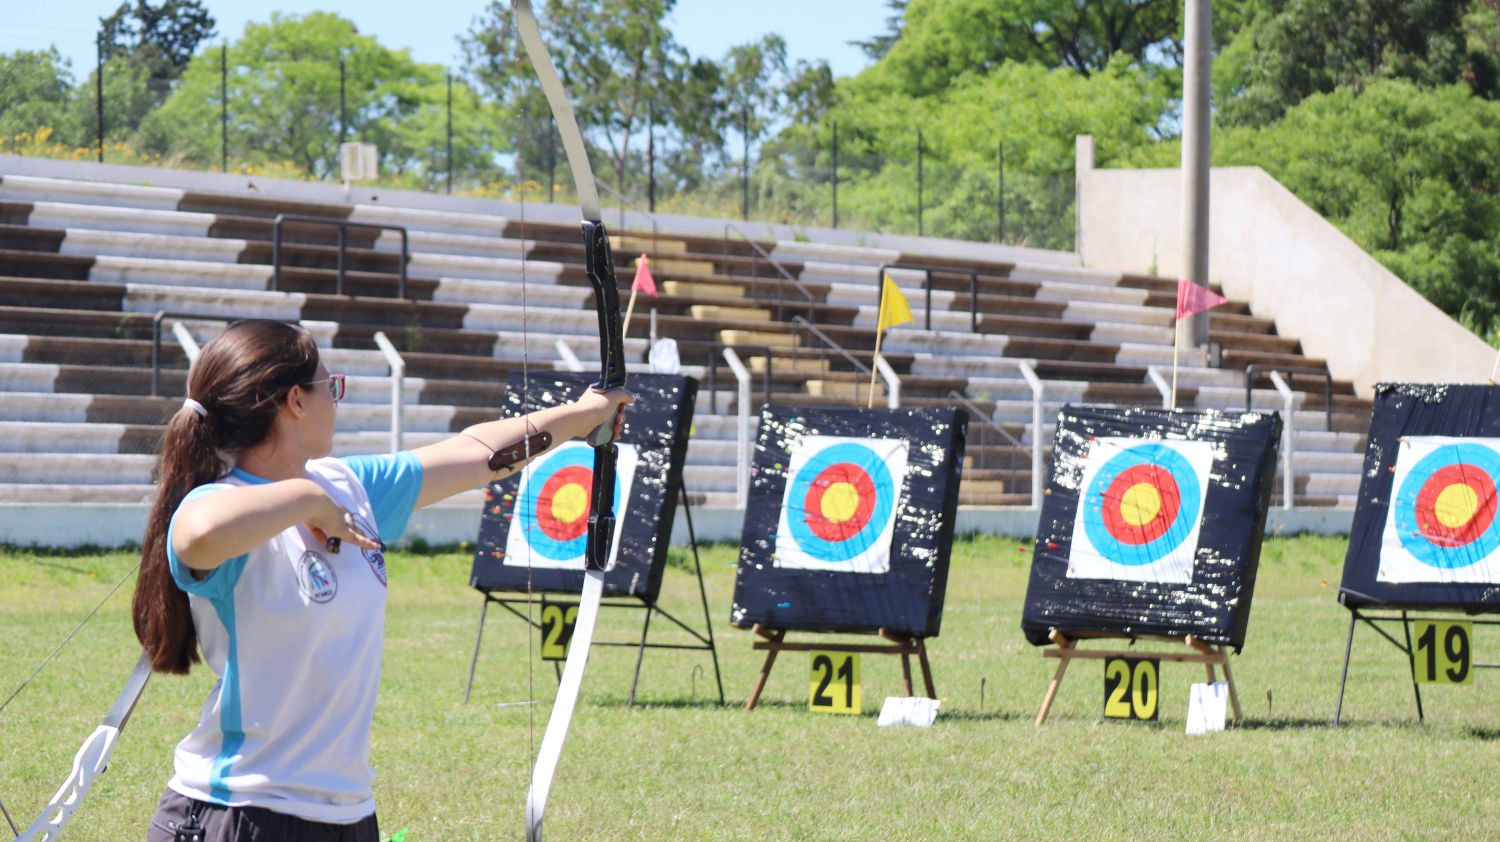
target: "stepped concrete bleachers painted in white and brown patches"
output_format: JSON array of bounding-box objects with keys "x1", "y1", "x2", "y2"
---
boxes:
[{"x1": 0, "y1": 165, "x2": 1370, "y2": 546}]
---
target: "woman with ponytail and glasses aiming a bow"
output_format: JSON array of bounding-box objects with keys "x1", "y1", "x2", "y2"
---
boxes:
[{"x1": 132, "y1": 320, "x2": 632, "y2": 842}]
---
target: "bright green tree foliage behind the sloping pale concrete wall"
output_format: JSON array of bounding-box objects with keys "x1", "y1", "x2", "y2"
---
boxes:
[{"x1": 1133, "y1": 80, "x2": 1500, "y2": 335}]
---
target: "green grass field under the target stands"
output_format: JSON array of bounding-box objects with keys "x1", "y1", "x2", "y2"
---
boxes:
[{"x1": 0, "y1": 537, "x2": 1500, "y2": 842}]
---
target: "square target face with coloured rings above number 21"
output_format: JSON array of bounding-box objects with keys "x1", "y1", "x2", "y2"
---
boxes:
[{"x1": 776, "y1": 435, "x2": 906, "y2": 573}]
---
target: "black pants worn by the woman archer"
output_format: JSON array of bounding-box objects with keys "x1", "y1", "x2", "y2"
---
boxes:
[{"x1": 146, "y1": 786, "x2": 380, "y2": 842}]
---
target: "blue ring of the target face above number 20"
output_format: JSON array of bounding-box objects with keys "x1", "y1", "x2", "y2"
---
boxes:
[{"x1": 1080, "y1": 444, "x2": 1202, "y2": 567}]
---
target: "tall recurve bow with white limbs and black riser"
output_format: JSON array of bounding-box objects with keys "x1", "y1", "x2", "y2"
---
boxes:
[{"x1": 512, "y1": 0, "x2": 626, "y2": 842}]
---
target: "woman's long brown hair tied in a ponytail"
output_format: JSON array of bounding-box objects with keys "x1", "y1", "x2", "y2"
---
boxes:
[{"x1": 132, "y1": 320, "x2": 318, "y2": 674}]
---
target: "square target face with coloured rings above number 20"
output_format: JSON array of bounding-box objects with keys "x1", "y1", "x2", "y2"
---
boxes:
[{"x1": 1068, "y1": 438, "x2": 1214, "y2": 584}]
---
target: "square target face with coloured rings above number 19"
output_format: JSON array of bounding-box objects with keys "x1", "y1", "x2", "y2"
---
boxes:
[{"x1": 1376, "y1": 435, "x2": 1500, "y2": 584}]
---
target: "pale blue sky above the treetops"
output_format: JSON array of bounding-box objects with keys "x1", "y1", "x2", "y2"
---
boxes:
[{"x1": 0, "y1": 0, "x2": 888, "y2": 78}]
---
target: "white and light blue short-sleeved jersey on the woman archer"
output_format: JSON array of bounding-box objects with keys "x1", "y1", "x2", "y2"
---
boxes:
[{"x1": 167, "y1": 453, "x2": 422, "y2": 824}]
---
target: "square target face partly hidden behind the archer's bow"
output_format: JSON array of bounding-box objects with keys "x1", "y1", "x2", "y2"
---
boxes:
[{"x1": 503, "y1": 441, "x2": 639, "y2": 570}]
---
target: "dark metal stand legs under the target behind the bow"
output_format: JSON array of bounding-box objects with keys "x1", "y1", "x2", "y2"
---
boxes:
[{"x1": 464, "y1": 485, "x2": 725, "y2": 708}]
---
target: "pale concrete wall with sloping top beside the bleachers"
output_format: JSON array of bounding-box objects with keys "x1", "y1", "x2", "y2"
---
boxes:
[{"x1": 1077, "y1": 141, "x2": 1496, "y2": 396}]
